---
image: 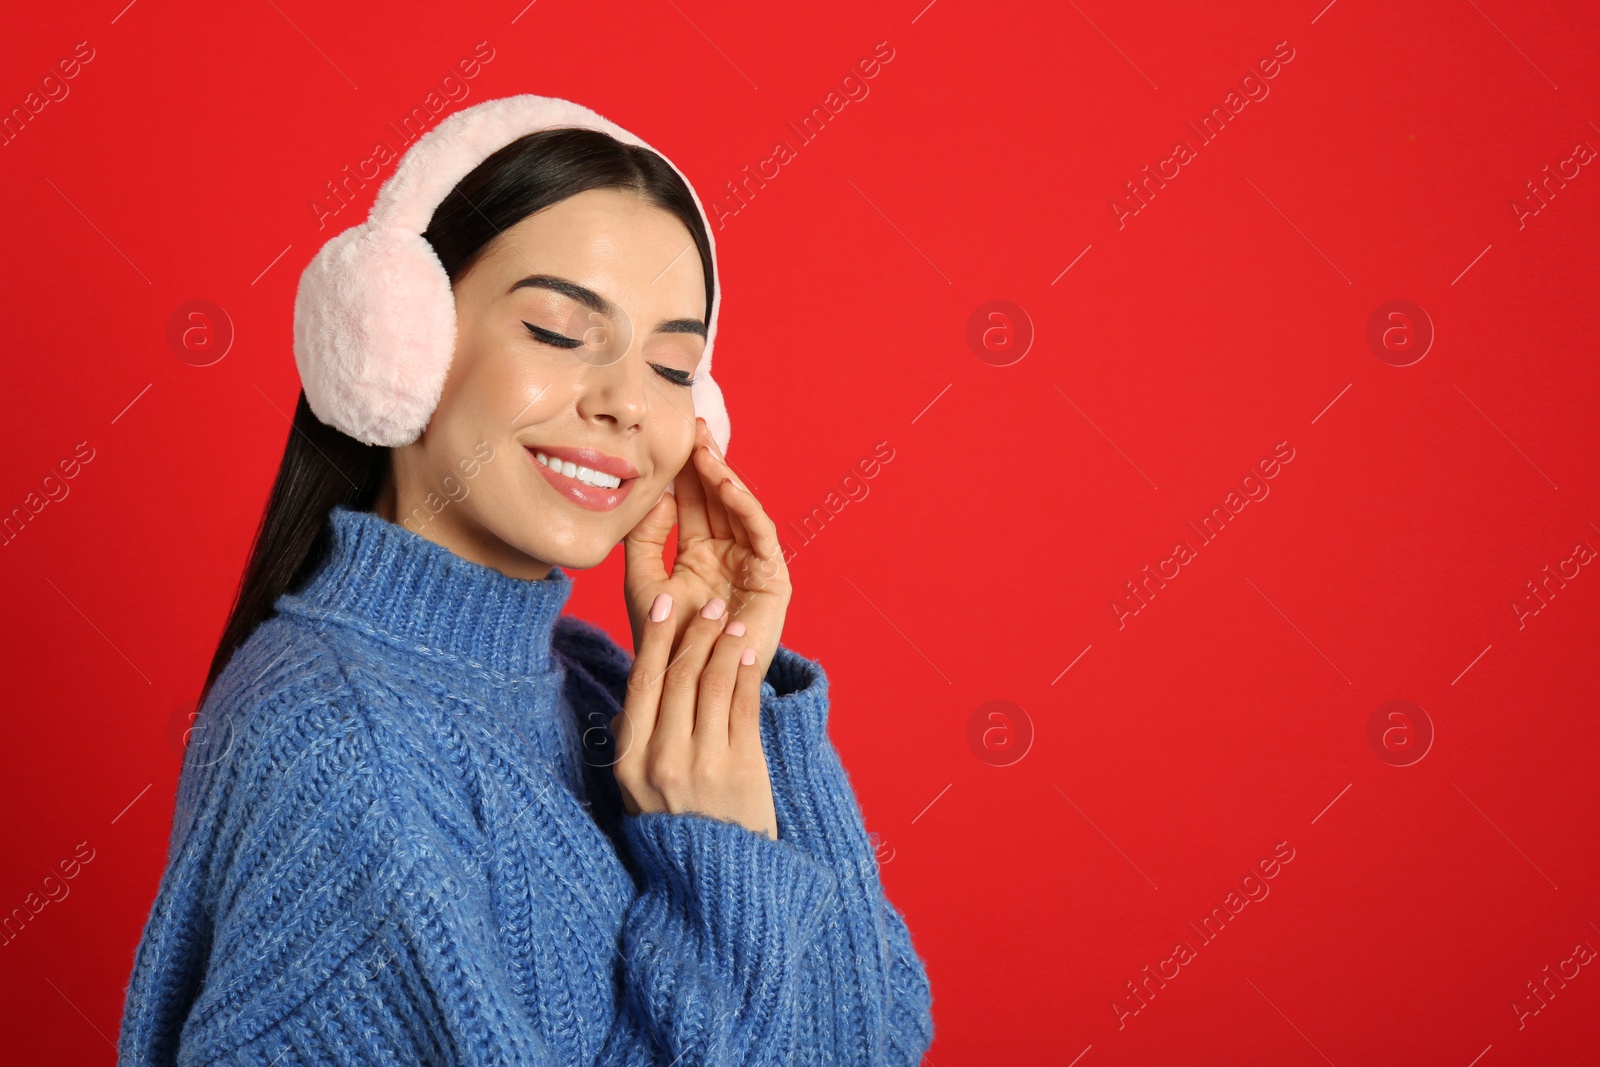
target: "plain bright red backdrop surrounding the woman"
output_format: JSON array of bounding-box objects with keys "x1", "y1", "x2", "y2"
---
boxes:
[{"x1": 0, "y1": 0, "x2": 1600, "y2": 1067}]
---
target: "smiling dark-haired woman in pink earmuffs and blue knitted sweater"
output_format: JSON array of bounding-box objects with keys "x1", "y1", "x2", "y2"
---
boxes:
[{"x1": 120, "y1": 96, "x2": 931, "y2": 1067}]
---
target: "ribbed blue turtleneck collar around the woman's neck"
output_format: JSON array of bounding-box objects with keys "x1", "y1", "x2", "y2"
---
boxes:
[{"x1": 278, "y1": 504, "x2": 573, "y2": 677}]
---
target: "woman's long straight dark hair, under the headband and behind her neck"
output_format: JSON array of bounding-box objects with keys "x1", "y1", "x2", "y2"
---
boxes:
[{"x1": 200, "y1": 128, "x2": 717, "y2": 704}]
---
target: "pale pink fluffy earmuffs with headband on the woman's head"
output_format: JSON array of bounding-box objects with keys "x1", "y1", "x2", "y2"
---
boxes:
[{"x1": 294, "y1": 94, "x2": 731, "y2": 453}]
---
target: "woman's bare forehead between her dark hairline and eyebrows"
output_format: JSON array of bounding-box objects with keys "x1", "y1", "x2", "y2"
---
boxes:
[{"x1": 480, "y1": 189, "x2": 706, "y2": 315}]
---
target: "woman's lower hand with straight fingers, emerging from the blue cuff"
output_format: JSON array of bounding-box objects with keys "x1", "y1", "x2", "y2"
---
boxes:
[{"x1": 611, "y1": 593, "x2": 778, "y2": 840}]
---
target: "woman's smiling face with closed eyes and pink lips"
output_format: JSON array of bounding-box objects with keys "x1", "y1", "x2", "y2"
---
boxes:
[{"x1": 378, "y1": 189, "x2": 706, "y2": 579}]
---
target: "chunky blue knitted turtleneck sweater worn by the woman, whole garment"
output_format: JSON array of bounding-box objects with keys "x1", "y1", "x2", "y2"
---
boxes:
[{"x1": 118, "y1": 507, "x2": 933, "y2": 1067}]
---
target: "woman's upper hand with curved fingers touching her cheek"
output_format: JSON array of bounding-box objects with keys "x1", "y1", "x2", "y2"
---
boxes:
[{"x1": 622, "y1": 416, "x2": 794, "y2": 678}]
